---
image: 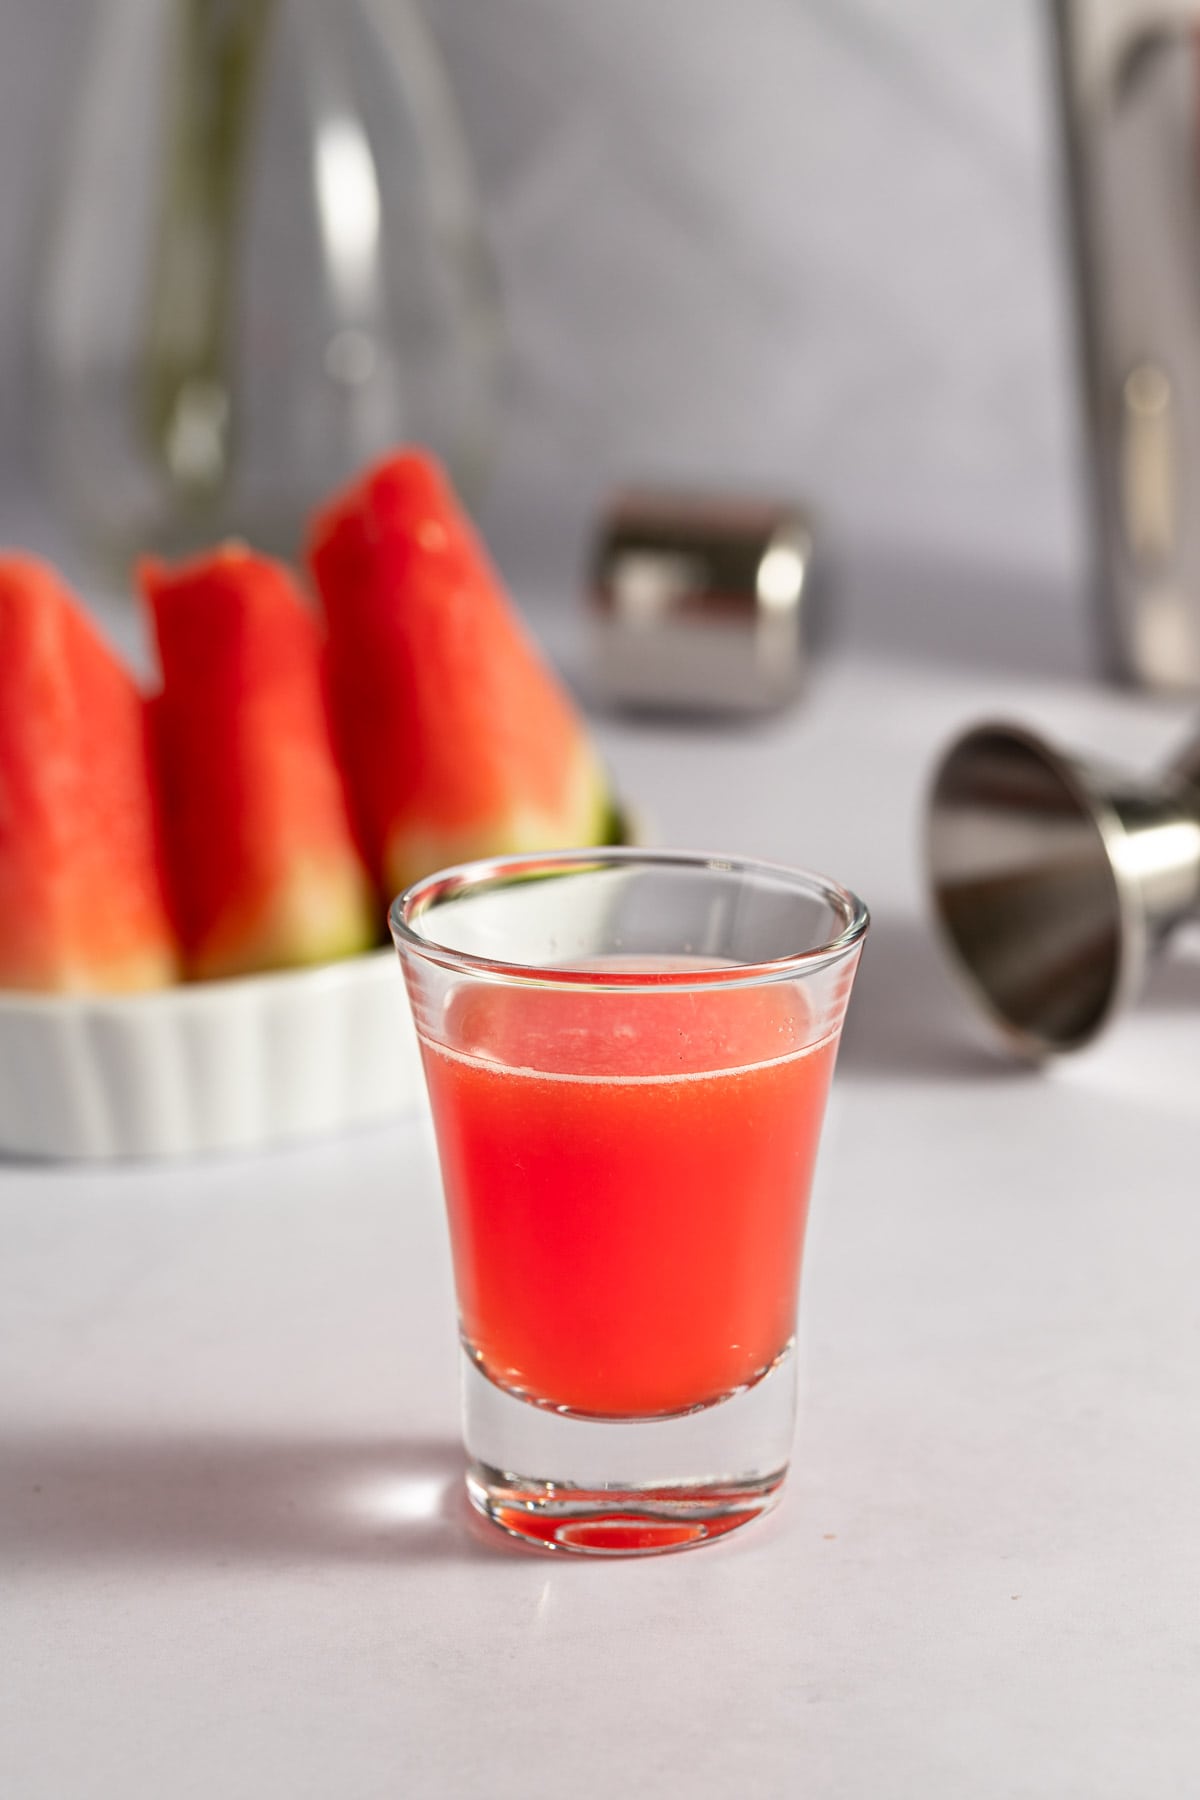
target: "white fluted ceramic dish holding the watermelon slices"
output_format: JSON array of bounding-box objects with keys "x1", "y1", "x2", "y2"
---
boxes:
[{"x1": 0, "y1": 949, "x2": 425, "y2": 1157}]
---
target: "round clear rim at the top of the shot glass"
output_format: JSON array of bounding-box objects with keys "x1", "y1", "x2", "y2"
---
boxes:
[{"x1": 387, "y1": 844, "x2": 871, "y2": 994}]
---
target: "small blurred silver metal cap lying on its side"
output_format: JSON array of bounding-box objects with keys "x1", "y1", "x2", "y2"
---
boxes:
[{"x1": 590, "y1": 491, "x2": 813, "y2": 713}]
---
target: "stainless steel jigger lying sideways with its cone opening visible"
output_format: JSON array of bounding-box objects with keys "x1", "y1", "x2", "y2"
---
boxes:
[{"x1": 927, "y1": 724, "x2": 1200, "y2": 1058}]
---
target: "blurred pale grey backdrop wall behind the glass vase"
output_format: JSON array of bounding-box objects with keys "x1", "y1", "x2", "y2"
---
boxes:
[{"x1": 0, "y1": 0, "x2": 1081, "y2": 603}]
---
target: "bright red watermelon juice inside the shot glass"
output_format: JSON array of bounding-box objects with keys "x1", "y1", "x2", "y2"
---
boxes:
[{"x1": 423, "y1": 961, "x2": 837, "y2": 1418}]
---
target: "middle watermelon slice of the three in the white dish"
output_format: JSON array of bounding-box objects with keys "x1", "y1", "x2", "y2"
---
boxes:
[{"x1": 139, "y1": 545, "x2": 378, "y2": 977}]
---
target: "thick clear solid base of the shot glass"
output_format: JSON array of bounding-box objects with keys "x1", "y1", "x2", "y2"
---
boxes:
[{"x1": 462, "y1": 1345, "x2": 795, "y2": 1557}]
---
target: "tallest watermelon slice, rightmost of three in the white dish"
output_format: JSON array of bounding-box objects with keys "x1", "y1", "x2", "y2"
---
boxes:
[{"x1": 309, "y1": 450, "x2": 612, "y2": 893}]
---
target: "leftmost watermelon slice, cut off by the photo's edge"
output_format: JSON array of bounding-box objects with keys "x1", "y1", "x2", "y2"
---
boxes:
[{"x1": 0, "y1": 554, "x2": 176, "y2": 992}]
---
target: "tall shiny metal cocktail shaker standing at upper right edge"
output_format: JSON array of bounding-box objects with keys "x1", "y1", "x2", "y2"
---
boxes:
[{"x1": 1054, "y1": 0, "x2": 1200, "y2": 693}]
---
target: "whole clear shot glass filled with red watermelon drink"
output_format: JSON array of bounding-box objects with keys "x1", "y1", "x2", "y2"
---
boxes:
[{"x1": 390, "y1": 850, "x2": 867, "y2": 1555}]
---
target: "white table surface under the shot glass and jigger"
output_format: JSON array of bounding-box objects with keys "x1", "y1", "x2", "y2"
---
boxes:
[{"x1": 0, "y1": 579, "x2": 1200, "y2": 1800}]
